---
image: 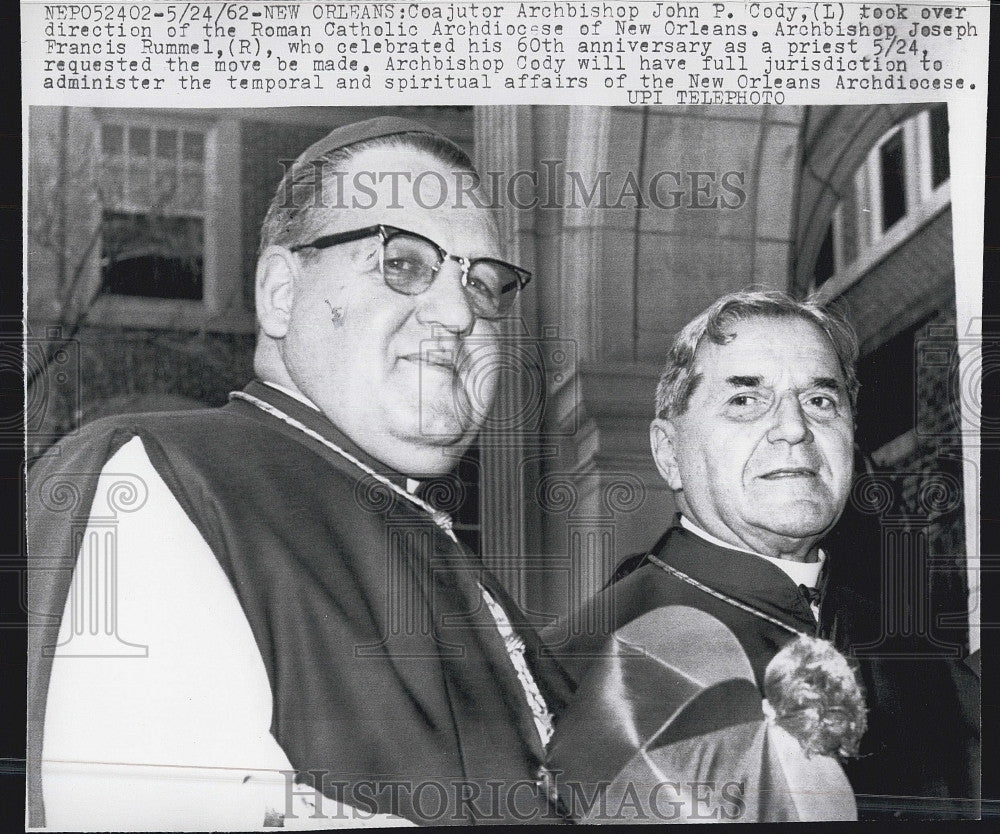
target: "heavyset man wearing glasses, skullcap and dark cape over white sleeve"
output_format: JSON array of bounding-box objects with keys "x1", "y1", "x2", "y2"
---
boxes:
[{"x1": 28, "y1": 118, "x2": 566, "y2": 830}]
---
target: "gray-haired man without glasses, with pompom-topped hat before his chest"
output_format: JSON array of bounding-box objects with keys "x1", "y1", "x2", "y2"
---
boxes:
[{"x1": 550, "y1": 291, "x2": 978, "y2": 822}]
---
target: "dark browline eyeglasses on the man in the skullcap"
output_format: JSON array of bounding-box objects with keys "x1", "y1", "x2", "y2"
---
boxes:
[{"x1": 289, "y1": 224, "x2": 531, "y2": 319}]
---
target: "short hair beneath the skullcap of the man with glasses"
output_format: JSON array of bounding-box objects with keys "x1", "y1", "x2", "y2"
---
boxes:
[{"x1": 258, "y1": 131, "x2": 478, "y2": 256}]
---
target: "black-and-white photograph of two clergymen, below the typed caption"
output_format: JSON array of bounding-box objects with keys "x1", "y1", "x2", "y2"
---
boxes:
[{"x1": 19, "y1": 100, "x2": 981, "y2": 830}]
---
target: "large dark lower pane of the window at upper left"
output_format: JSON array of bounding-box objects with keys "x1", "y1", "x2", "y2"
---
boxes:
[{"x1": 101, "y1": 211, "x2": 204, "y2": 300}]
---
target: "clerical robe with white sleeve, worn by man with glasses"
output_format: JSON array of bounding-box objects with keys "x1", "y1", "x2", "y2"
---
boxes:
[{"x1": 28, "y1": 383, "x2": 565, "y2": 827}]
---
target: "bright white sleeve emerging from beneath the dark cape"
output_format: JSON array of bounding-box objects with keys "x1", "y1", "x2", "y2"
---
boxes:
[{"x1": 42, "y1": 437, "x2": 414, "y2": 831}]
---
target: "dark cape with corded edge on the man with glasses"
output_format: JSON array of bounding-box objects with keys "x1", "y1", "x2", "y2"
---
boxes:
[{"x1": 28, "y1": 383, "x2": 567, "y2": 825}]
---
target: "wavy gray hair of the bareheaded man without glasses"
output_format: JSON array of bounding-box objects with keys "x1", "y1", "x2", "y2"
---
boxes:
[{"x1": 656, "y1": 290, "x2": 860, "y2": 419}]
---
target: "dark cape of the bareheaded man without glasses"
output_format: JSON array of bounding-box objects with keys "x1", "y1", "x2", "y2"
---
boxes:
[{"x1": 552, "y1": 524, "x2": 978, "y2": 819}]
